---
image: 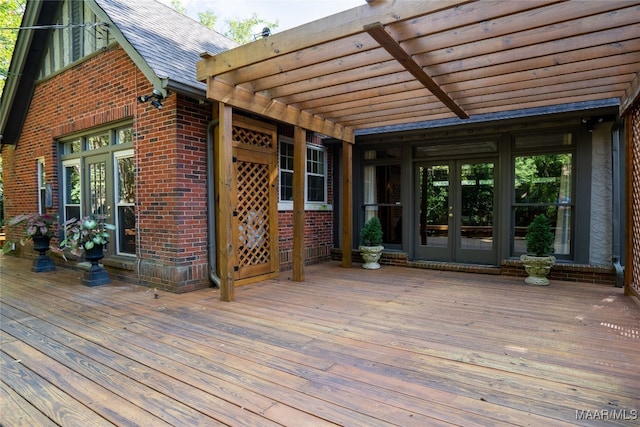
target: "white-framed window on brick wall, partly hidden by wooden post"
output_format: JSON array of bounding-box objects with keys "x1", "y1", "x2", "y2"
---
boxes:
[{"x1": 279, "y1": 140, "x2": 328, "y2": 210}]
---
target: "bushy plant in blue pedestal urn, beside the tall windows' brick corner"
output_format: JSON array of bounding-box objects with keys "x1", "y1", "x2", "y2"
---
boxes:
[{"x1": 56, "y1": 215, "x2": 116, "y2": 286}]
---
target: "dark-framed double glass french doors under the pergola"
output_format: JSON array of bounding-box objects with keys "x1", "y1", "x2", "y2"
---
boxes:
[{"x1": 414, "y1": 160, "x2": 497, "y2": 264}]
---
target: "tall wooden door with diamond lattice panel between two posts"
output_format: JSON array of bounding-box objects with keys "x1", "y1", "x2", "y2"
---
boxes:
[{"x1": 232, "y1": 116, "x2": 280, "y2": 285}]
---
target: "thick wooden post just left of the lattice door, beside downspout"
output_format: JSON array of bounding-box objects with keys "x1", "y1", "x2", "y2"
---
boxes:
[{"x1": 213, "y1": 102, "x2": 236, "y2": 301}]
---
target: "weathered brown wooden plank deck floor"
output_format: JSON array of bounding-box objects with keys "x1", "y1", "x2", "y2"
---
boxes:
[{"x1": 0, "y1": 256, "x2": 640, "y2": 427}]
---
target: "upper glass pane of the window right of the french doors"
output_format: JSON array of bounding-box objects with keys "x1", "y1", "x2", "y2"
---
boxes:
[{"x1": 514, "y1": 153, "x2": 572, "y2": 204}]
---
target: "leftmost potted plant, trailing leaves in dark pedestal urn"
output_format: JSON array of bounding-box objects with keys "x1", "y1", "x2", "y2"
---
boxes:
[{"x1": 2, "y1": 213, "x2": 59, "y2": 273}]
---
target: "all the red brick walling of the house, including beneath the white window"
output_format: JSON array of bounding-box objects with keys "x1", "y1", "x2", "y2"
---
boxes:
[{"x1": 2, "y1": 47, "x2": 333, "y2": 292}]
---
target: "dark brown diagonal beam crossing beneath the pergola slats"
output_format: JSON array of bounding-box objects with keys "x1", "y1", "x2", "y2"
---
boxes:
[{"x1": 364, "y1": 22, "x2": 469, "y2": 119}]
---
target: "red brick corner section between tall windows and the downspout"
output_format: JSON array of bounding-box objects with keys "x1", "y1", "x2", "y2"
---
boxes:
[{"x1": 135, "y1": 94, "x2": 211, "y2": 292}]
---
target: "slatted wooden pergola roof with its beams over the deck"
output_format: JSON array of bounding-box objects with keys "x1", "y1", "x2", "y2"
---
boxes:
[{"x1": 197, "y1": 0, "x2": 640, "y2": 142}]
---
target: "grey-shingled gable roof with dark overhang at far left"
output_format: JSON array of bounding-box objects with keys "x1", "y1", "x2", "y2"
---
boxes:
[{"x1": 0, "y1": 0, "x2": 237, "y2": 145}]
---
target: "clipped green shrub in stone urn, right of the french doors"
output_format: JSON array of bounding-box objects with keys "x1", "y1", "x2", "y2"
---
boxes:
[{"x1": 520, "y1": 215, "x2": 556, "y2": 285}]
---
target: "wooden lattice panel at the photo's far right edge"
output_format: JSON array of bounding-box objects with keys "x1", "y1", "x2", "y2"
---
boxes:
[{"x1": 625, "y1": 103, "x2": 640, "y2": 297}]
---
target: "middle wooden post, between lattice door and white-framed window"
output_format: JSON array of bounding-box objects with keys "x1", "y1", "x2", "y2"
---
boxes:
[{"x1": 293, "y1": 126, "x2": 307, "y2": 282}]
